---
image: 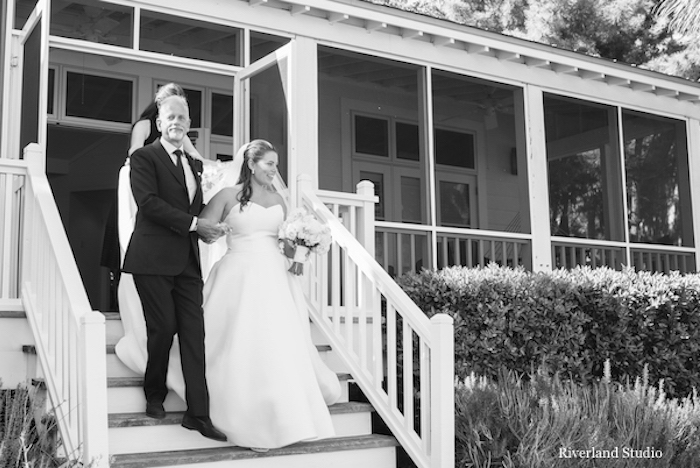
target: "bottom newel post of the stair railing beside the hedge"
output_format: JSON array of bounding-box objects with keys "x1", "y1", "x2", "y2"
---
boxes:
[{"x1": 430, "y1": 314, "x2": 455, "y2": 468}]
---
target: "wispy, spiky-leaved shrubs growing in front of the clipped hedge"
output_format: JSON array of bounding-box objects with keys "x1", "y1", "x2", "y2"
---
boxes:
[{"x1": 455, "y1": 370, "x2": 700, "y2": 468}]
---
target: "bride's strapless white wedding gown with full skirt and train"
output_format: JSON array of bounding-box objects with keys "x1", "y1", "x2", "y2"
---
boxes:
[{"x1": 116, "y1": 168, "x2": 341, "y2": 448}]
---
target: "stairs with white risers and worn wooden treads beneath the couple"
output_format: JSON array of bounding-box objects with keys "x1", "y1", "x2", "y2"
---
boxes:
[{"x1": 98, "y1": 313, "x2": 398, "y2": 468}]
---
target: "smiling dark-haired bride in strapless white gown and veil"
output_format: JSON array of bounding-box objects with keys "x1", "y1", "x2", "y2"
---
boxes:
[{"x1": 117, "y1": 140, "x2": 340, "y2": 451}]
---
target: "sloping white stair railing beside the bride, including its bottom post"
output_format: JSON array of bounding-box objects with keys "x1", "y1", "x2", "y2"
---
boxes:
[{"x1": 298, "y1": 175, "x2": 454, "y2": 468}]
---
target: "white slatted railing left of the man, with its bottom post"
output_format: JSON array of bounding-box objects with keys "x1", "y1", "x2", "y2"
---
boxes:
[{"x1": 0, "y1": 144, "x2": 109, "y2": 467}]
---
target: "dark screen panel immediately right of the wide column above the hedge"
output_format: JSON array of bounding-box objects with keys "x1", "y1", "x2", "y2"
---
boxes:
[{"x1": 544, "y1": 95, "x2": 624, "y2": 241}]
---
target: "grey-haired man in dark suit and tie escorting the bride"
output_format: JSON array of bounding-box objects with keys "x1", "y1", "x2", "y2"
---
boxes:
[{"x1": 124, "y1": 96, "x2": 226, "y2": 441}]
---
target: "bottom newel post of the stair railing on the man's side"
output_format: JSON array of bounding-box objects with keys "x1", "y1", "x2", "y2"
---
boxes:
[{"x1": 80, "y1": 311, "x2": 109, "y2": 468}]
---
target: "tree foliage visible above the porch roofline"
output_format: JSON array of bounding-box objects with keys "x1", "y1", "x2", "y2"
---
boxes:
[{"x1": 368, "y1": 0, "x2": 700, "y2": 80}]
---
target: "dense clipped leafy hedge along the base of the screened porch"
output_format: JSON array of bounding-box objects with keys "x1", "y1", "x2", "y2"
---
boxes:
[{"x1": 398, "y1": 264, "x2": 700, "y2": 397}]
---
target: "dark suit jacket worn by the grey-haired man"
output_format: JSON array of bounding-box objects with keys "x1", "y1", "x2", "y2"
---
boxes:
[{"x1": 123, "y1": 139, "x2": 204, "y2": 276}]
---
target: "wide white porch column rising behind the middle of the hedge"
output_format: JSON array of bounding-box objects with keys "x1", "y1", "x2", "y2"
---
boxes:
[{"x1": 524, "y1": 85, "x2": 552, "y2": 271}]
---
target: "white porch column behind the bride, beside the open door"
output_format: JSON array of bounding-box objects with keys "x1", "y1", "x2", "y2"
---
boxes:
[{"x1": 289, "y1": 37, "x2": 318, "y2": 197}]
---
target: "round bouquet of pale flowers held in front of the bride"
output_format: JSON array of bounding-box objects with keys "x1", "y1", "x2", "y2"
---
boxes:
[{"x1": 277, "y1": 208, "x2": 331, "y2": 276}]
